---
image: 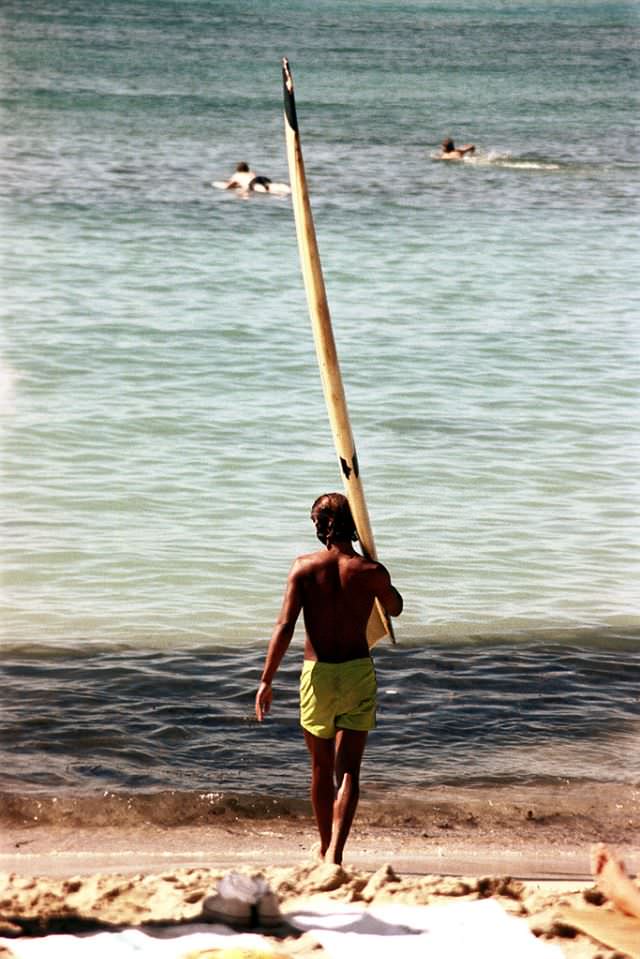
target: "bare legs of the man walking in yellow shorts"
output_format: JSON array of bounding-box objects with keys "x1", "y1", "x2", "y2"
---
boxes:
[{"x1": 304, "y1": 729, "x2": 367, "y2": 864}]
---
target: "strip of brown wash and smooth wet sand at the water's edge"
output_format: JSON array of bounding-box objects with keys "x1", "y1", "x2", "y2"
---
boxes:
[{"x1": 0, "y1": 783, "x2": 640, "y2": 880}]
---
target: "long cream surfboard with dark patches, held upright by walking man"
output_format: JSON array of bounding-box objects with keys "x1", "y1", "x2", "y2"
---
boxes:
[{"x1": 282, "y1": 58, "x2": 394, "y2": 646}]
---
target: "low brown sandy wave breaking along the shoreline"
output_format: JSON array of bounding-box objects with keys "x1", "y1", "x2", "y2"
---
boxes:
[{"x1": 0, "y1": 777, "x2": 637, "y2": 836}]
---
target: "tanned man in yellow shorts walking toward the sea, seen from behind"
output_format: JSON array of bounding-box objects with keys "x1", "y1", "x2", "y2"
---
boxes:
[{"x1": 255, "y1": 493, "x2": 403, "y2": 863}]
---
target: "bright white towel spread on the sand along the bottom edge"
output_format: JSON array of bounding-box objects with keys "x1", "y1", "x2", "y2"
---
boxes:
[{"x1": 0, "y1": 899, "x2": 563, "y2": 959}]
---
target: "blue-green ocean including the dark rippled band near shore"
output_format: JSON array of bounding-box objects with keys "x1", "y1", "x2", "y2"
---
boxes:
[{"x1": 0, "y1": 0, "x2": 640, "y2": 808}]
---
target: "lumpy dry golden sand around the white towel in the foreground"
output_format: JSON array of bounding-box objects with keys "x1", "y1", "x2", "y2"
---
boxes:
[{"x1": 0, "y1": 862, "x2": 640, "y2": 959}]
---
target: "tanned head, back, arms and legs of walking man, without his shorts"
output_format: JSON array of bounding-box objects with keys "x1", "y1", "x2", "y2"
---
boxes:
[{"x1": 256, "y1": 493, "x2": 403, "y2": 863}]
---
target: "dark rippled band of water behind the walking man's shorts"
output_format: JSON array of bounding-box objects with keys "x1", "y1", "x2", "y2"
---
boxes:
[{"x1": 2, "y1": 643, "x2": 640, "y2": 797}]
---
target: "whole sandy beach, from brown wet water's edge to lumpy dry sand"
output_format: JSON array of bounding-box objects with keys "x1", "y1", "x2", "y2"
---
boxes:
[{"x1": 0, "y1": 787, "x2": 640, "y2": 959}]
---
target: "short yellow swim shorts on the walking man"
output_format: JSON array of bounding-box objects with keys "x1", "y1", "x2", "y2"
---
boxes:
[{"x1": 300, "y1": 656, "x2": 378, "y2": 739}]
